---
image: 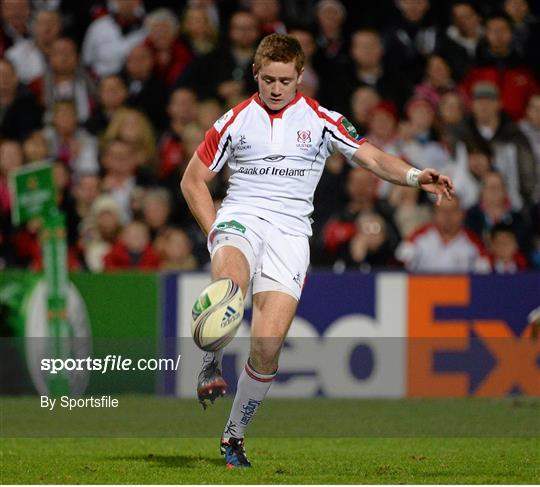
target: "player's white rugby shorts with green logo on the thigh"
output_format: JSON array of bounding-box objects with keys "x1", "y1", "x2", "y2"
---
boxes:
[{"x1": 208, "y1": 214, "x2": 309, "y2": 301}]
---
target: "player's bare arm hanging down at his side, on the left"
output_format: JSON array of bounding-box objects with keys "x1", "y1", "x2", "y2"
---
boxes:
[{"x1": 180, "y1": 153, "x2": 216, "y2": 235}]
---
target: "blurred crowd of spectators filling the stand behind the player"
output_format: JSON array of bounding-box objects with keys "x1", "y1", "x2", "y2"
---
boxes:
[{"x1": 0, "y1": 0, "x2": 540, "y2": 273}]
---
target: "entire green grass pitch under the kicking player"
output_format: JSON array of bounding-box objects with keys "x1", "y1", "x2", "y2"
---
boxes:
[{"x1": 0, "y1": 396, "x2": 540, "y2": 484}]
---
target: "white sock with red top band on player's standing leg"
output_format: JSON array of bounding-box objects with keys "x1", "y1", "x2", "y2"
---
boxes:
[{"x1": 223, "y1": 361, "x2": 276, "y2": 439}]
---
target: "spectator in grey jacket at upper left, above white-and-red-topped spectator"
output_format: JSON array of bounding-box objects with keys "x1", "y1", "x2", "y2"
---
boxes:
[{"x1": 29, "y1": 37, "x2": 95, "y2": 123}]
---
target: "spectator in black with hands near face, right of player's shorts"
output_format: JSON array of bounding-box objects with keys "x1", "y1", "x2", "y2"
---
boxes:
[{"x1": 333, "y1": 212, "x2": 399, "y2": 272}]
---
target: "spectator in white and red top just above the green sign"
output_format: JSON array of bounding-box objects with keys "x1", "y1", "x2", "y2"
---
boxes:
[{"x1": 43, "y1": 101, "x2": 99, "y2": 176}]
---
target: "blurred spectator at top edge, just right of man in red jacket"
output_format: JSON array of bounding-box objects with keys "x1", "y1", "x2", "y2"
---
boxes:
[{"x1": 181, "y1": 5, "x2": 218, "y2": 57}]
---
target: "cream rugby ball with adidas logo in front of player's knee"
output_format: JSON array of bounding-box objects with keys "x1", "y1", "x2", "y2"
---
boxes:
[{"x1": 191, "y1": 278, "x2": 244, "y2": 352}]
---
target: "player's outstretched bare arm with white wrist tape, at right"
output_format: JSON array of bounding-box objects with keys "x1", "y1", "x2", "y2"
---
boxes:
[{"x1": 353, "y1": 142, "x2": 454, "y2": 205}]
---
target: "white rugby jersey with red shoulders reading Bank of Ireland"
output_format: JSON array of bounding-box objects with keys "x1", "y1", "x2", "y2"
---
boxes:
[{"x1": 197, "y1": 93, "x2": 365, "y2": 236}]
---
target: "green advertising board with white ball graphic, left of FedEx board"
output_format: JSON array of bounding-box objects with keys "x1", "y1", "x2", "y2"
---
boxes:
[{"x1": 0, "y1": 270, "x2": 162, "y2": 394}]
